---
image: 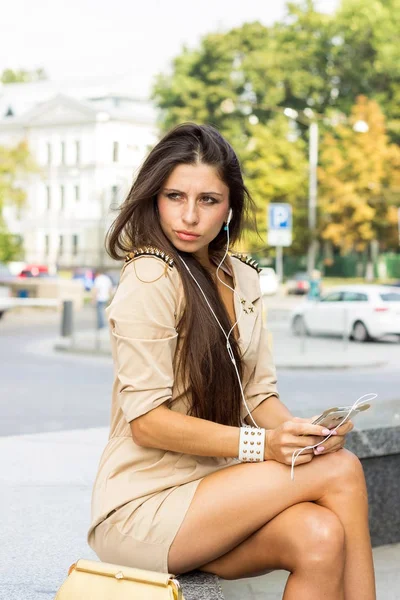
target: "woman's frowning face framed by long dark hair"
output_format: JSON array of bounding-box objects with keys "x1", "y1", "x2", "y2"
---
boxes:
[{"x1": 157, "y1": 163, "x2": 229, "y2": 258}]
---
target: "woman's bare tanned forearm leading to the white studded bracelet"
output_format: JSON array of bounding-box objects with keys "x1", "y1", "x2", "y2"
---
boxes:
[{"x1": 130, "y1": 404, "x2": 240, "y2": 458}]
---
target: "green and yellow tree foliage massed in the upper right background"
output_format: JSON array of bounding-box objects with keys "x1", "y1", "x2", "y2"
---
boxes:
[{"x1": 153, "y1": 0, "x2": 400, "y2": 253}]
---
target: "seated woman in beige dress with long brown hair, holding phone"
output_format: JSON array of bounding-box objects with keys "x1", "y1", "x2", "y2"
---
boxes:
[{"x1": 88, "y1": 123, "x2": 375, "y2": 600}]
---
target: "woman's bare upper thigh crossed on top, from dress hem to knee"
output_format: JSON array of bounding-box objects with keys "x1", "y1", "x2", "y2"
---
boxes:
[{"x1": 168, "y1": 449, "x2": 362, "y2": 573}]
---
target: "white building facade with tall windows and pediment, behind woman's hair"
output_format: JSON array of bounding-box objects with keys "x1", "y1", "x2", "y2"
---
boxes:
[{"x1": 0, "y1": 84, "x2": 157, "y2": 270}]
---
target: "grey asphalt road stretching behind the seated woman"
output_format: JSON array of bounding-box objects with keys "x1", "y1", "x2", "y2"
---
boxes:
[{"x1": 0, "y1": 309, "x2": 400, "y2": 436}]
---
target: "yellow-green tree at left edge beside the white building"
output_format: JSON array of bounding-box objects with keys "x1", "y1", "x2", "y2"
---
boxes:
[{"x1": 0, "y1": 141, "x2": 37, "y2": 262}]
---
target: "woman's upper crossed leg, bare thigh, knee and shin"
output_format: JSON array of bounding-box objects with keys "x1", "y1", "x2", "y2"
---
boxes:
[{"x1": 169, "y1": 450, "x2": 375, "y2": 600}]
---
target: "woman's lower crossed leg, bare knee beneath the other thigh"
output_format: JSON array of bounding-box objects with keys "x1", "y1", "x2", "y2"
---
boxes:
[{"x1": 200, "y1": 502, "x2": 345, "y2": 600}]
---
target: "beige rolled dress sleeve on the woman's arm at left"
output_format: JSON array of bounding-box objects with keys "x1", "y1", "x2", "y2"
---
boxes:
[{"x1": 108, "y1": 256, "x2": 178, "y2": 423}]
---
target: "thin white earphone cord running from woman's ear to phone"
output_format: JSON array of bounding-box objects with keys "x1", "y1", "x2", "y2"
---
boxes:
[{"x1": 178, "y1": 208, "x2": 377, "y2": 481}]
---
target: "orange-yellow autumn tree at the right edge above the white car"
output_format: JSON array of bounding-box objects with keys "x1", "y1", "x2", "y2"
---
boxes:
[{"x1": 318, "y1": 96, "x2": 400, "y2": 253}]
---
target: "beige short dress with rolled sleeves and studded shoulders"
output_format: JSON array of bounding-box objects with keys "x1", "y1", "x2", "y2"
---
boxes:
[{"x1": 88, "y1": 247, "x2": 278, "y2": 572}]
